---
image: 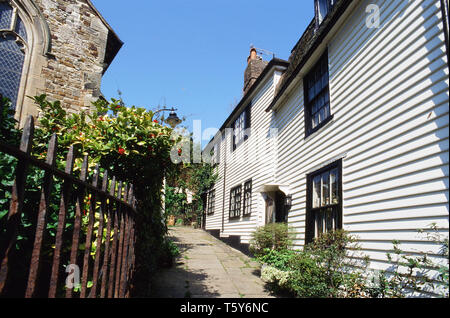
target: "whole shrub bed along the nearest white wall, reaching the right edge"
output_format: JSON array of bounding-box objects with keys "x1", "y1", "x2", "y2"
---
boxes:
[{"x1": 257, "y1": 225, "x2": 449, "y2": 298}]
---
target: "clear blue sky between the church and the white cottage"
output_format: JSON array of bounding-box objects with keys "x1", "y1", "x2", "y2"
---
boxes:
[{"x1": 93, "y1": 0, "x2": 314, "y2": 135}]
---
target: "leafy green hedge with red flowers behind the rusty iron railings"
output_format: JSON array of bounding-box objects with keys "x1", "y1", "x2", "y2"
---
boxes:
[{"x1": 0, "y1": 95, "x2": 185, "y2": 293}]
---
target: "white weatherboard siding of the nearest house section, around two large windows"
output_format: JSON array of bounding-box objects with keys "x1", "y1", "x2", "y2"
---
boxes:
[{"x1": 271, "y1": 0, "x2": 449, "y2": 268}]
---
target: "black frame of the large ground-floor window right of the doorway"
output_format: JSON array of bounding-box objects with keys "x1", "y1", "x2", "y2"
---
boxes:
[{"x1": 305, "y1": 159, "x2": 343, "y2": 244}]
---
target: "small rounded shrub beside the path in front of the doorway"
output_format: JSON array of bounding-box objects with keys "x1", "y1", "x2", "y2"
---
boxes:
[{"x1": 250, "y1": 223, "x2": 292, "y2": 257}]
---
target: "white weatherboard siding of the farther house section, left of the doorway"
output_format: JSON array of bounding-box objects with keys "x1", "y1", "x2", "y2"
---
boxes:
[{"x1": 206, "y1": 71, "x2": 280, "y2": 243}]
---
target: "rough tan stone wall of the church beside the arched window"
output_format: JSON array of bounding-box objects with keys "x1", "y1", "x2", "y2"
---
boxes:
[{"x1": 17, "y1": 0, "x2": 121, "y2": 124}]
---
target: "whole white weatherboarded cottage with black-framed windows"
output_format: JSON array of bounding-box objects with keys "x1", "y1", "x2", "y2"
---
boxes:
[{"x1": 205, "y1": 0, "x2": 449, "y2": 276}]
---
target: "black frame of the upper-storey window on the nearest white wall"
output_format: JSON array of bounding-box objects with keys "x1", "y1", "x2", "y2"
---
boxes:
[{"x1": 303, "y1": 50, "x2": 334, "y2": 139}]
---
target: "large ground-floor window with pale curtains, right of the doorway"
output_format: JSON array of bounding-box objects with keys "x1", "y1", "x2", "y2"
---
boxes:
[{"x1": 306, "y1": 161, "x2": 342, "y2": 243}]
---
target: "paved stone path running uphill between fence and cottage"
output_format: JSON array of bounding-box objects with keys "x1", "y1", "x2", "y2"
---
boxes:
[{"x1": 152, "y1": 227, "x2": 272, "y2": 298}]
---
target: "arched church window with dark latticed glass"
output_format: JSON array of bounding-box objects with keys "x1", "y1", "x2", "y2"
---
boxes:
[{"x1": 0, "y1": 1, "x2": 28, "y2": 108}]
